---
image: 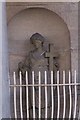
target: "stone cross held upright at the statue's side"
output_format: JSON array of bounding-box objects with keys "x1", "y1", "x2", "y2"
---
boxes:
[{"x1": 45, "y1": 44, "x2": 59, "y2": 71}]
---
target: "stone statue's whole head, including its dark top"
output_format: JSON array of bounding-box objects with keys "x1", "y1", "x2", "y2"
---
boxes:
[{"x1": 30, "y1": 33, "x2": 45, "y2": 48}]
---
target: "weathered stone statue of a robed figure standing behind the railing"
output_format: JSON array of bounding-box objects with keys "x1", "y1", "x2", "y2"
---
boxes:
[{"x1": 18, "y1": 33, "x2": 58, "y2": 118}]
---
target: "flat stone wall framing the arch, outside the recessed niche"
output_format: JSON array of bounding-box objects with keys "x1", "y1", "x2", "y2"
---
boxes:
[{"x1": 7, "y1": 3, "x2": 78, "y2": 75}]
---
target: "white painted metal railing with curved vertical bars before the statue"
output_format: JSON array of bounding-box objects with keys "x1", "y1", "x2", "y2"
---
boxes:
[{"x1": 10, "y1": 71, "x2": 80, "y2": 119}]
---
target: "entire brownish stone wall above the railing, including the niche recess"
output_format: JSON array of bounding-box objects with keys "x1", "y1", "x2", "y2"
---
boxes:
[{"x1": 7, "y1": 2, "x2": 78, "y2": 118}]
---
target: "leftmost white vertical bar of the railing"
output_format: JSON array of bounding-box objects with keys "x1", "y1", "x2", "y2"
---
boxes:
[{"x1": 13, "y1": 72, "x2": 17, "y2": 118}]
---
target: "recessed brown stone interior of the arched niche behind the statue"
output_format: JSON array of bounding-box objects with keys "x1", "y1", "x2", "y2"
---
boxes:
[{"x1": 8, "y1": 8, "x2": 70, "y2": 72}]
